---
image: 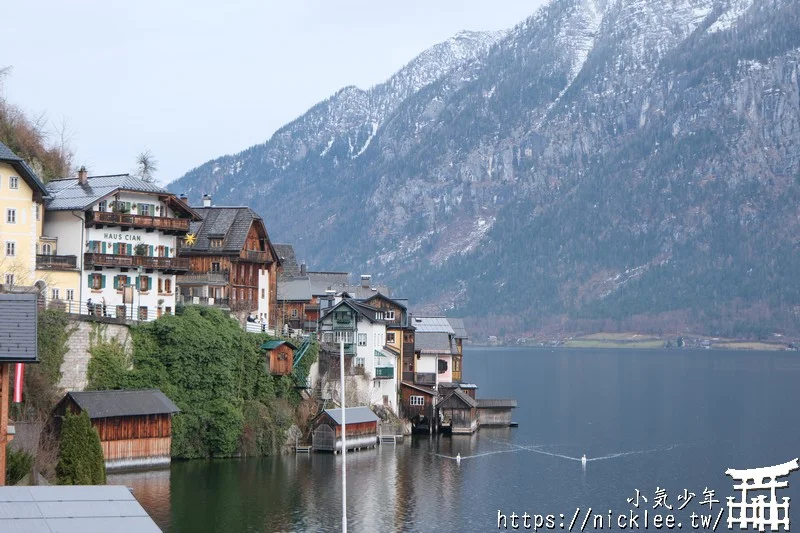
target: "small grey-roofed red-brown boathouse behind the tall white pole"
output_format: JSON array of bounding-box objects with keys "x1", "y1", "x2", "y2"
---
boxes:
[{"x1": 311, "y1": 407, "x2": 380, "y2": 453}]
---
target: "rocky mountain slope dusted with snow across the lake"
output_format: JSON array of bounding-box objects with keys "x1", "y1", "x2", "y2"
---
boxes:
[{"x1": 171, "y1": 0, "x2": 800, "y2": 336}]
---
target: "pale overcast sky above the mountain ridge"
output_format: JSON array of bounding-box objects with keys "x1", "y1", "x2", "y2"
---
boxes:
[{"x1": 0, "y1": 0, "x2": 544, "y2": 183}]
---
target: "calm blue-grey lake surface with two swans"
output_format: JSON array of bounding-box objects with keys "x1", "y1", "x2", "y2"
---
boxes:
[{"x1": 109, "y1": 348, "x2": 800, "y2": 533}]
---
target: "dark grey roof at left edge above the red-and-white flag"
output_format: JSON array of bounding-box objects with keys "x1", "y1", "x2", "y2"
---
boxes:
[{"x1": 0, "y1": 293, "x2": 39, "y2": 363}]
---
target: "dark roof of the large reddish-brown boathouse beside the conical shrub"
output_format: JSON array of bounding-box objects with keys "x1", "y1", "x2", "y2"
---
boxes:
[{"x1": 67, "y1": 389, "x2": 180, "y2": 419}]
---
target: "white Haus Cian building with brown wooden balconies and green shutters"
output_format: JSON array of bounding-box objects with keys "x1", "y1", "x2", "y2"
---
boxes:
[{"x1": 43, "y1": 169, "x2": 199, "y2": 320}]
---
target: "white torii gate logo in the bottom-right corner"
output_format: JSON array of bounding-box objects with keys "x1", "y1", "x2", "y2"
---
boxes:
[{"x1": 725, "y1": 459, "x2": 800, "y2": 531}]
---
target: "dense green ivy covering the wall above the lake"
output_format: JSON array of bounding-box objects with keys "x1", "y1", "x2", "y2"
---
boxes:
[{"x1": 88, "y1": 306, "x2": 316, "y2": 459}]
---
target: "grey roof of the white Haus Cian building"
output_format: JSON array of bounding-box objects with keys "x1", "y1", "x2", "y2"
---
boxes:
[{"x1": 47, "y1": 174, "x2": 174, "y2": 211}]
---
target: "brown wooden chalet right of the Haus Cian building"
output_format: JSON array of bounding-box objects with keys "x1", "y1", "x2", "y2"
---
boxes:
[{"x1": 177, "y1": 196, "x2": 280, "y2": 328}]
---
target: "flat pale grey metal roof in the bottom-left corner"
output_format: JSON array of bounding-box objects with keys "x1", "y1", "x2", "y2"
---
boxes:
[{"x1": 0, "y1": 485, "x2": 161, "y2": 533}]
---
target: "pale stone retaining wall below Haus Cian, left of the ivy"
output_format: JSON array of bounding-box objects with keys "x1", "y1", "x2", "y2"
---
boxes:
[{"x1": 58, "y1": 318, "x2": 132, "y2": 392}]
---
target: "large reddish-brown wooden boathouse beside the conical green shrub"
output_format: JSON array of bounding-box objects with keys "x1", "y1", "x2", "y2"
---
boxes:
[{"x1": 54, "y1": 389, "x2": 179, "y2": 470}]
